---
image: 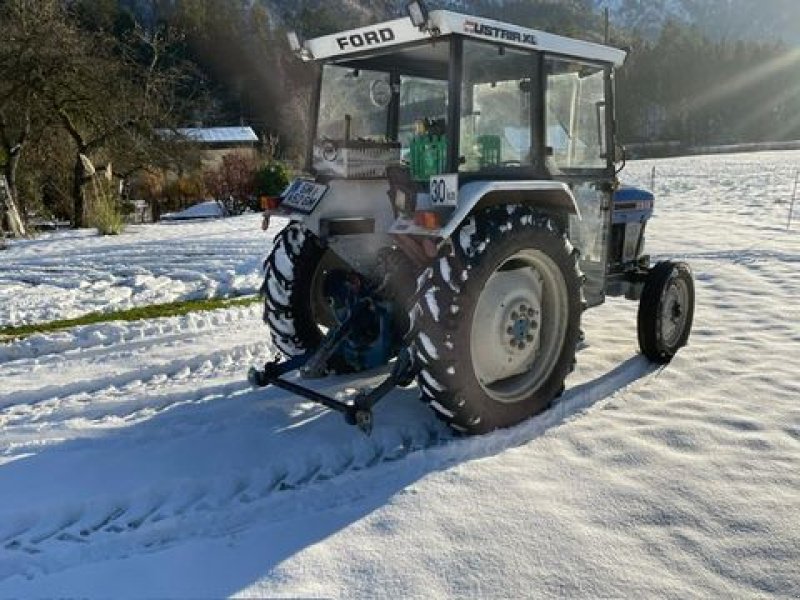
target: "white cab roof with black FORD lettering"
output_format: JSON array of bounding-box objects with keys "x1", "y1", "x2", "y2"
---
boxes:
[{"x1": 302, "y1": 10, "x2": 626, "y2": 66}]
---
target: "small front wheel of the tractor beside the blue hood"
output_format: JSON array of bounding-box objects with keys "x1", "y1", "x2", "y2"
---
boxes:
[{"x1": 637, "y1": 261, "x2": 695, "y2": 364}]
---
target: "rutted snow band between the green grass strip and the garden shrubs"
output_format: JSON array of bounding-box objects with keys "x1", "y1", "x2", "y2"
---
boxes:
[{"x1": 0, "y1": 215, "x2": 285, "y2": 327}]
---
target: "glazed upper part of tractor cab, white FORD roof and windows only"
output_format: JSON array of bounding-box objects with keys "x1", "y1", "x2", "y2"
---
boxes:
[{"x1": 304, "y1": 11, "x2": 625, "y2": 180}]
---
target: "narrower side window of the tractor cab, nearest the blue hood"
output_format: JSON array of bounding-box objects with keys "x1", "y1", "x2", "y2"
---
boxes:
[{"x1": 545, "y1": 59, "x2": 608, "y2": 169}]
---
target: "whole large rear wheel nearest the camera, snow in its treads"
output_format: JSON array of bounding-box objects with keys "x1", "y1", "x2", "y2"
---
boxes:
[{"x1": 412, "y1": 206, "x2": 583, "y2": 434}]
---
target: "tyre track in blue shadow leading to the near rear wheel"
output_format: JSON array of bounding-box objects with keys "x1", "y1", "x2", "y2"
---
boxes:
[{"x1": 0, "y1": 422, "x2": 452, "y2": 580}]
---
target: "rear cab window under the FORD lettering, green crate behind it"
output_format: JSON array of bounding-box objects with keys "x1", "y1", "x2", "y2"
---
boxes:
[{"x1": 313, "y1": 48, "x2": 449, "y2": 181}]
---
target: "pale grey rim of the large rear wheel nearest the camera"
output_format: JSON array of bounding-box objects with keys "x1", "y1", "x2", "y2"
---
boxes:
[{"x1": 470, "y1": 249, "x2": 569, "y2": 404}]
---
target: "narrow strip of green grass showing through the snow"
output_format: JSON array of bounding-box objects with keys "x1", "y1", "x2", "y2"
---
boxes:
[{"x1": 0, "y1": 296, "x2": 260, "y2": 341}]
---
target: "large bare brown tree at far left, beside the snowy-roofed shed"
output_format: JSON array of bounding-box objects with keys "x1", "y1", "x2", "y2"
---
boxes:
[{"x1": 0, "y1": 0, "x2": 191, "y2": 226}]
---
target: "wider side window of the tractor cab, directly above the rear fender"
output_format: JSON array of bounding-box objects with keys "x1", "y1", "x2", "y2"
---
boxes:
[{"x1": 459, "y1": 41, "x2": 534, "y2": 171}]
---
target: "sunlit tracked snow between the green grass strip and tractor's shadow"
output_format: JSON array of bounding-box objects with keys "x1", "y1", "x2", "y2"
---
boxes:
[{"x1": 0, "y1": 308, "x2": 274, "y2": 462}]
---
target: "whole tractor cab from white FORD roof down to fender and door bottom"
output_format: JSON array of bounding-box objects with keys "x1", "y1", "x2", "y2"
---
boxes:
[{"x1": 282, "y1": 11, "x2": 636, "y2": 305}]
